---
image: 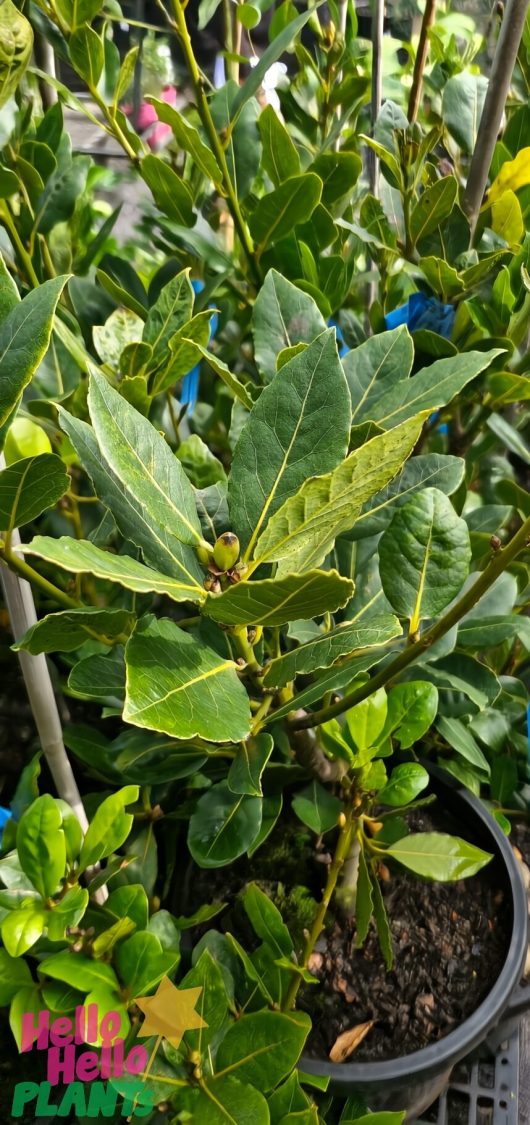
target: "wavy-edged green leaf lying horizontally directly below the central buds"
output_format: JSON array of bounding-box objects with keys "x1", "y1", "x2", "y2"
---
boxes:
[{"x1": 203, "y1": 570, "x2": 353, "y2": 626}]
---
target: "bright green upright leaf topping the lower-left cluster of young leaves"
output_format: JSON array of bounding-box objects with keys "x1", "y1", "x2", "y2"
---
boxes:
[{"x1": 17, "y1": 793, "x2": 66, "y2": 899}]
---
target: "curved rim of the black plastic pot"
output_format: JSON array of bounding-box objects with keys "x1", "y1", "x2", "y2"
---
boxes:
[{"x1": 298, "y1": 762, "x2": 529, "y2": 1087}]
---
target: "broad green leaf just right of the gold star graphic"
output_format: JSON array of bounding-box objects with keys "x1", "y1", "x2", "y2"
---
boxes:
[{"x1": 216, "y1": 1011, "x2": 311, "y2": 1092}]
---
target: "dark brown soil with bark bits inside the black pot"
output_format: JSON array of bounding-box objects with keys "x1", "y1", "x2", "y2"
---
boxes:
[{"x1": 181, "y1": 806, "x2": 510, "y2": 1062}]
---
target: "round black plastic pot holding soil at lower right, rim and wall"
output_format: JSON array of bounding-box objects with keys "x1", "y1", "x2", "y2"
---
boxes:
[{"x1": 299, "y1": 763, "x2": 530, "y2": 1121}]
